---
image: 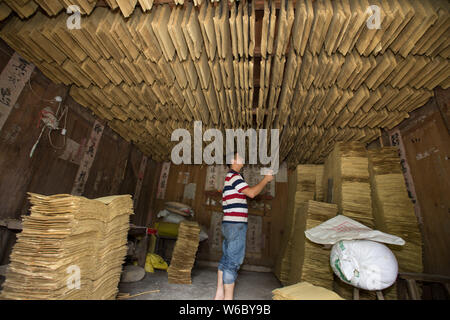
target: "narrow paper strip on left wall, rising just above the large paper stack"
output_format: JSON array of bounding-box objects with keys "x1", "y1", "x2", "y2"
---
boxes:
[{"x1": 72, "y1": 121, "x2": 105, "y2": 196}]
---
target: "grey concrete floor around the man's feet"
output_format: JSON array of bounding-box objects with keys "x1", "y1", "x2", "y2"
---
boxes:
[{"x1": 119, "y1": 266, "x2": 281, "y2": 300}]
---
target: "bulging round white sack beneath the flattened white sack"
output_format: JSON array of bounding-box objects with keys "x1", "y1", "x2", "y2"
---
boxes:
[{"x1": 330, "y1": 240, "x2": 398, "y2": 291}]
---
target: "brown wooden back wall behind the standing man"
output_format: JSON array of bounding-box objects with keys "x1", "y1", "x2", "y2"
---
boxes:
[{"x1": 153, "y1": 165, "x2": 290, "y2": 267}]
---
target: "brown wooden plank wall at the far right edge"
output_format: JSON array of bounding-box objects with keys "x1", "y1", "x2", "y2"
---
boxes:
[{"x1": 390, "y1": 89, "x2": 450, "y2": 276}]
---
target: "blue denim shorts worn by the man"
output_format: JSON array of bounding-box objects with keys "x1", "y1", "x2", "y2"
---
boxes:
[{"x1": 219, "y1": 222, "x2": 247, "y2": 284}]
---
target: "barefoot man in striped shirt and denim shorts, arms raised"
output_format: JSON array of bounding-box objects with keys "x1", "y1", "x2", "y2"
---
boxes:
[{"x1": 214, "y1": 153, "x2": 273, "y2": 300}]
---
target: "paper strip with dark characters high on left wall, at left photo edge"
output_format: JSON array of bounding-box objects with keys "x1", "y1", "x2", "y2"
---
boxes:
[{"x1": 0, "y1": 52, "x2": 34, "y2": 130}]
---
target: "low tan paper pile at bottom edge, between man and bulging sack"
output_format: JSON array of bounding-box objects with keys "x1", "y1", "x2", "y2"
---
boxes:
[{"x1": 272, "y1": 282, "x2": 344, "y2": 300}]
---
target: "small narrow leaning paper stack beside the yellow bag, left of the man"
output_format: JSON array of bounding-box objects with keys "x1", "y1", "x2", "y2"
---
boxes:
[{"x1": 167, "y1": 221, "x2": 200, "y2": 284}]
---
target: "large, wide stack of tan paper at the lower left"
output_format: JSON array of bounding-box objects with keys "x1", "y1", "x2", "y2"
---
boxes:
[{"x1": 1, "y1": 193, "x2": 133, "y2": 299}]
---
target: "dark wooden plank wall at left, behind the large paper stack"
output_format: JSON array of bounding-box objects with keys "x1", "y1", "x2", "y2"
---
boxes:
[{"x1": 0, "y1": 41, "x2": 159, "y2": 265}]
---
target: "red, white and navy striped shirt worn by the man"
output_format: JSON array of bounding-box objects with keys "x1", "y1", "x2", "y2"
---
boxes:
[{"x1": 222, "y1": 170, "x2": 248, "y2": 223}]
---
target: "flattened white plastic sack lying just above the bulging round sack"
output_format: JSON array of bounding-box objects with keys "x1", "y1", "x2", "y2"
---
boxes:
[{"x1": 305, "y1": 215, "x2": 405, "y2": 246}]
